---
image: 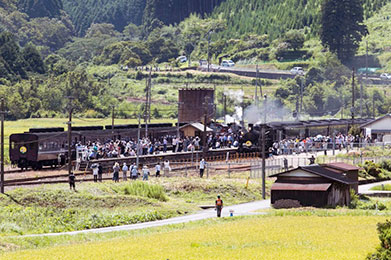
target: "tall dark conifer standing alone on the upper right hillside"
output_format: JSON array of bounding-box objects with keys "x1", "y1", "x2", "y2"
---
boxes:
[{"x1": 320, "y1": 0, "x2": 367, "y2": 63}]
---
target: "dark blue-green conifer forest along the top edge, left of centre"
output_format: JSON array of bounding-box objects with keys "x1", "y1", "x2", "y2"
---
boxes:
[{"x1": 63, "y1": 0, "x2": 223, "y2": 35}]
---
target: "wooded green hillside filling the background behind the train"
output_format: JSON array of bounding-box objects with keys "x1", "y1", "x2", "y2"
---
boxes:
[{"x1": 0, "y1": 0, "x2": 391, "y2": 119}]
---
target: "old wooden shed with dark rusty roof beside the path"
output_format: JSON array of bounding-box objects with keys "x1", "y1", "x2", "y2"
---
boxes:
[{"x1": 270, "y1": 164, "x2": 359, "y2": 207}]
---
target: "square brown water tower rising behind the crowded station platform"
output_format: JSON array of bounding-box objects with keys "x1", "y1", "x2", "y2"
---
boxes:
[{"x1": 178, "y1": 88, "x2": 215, "y2": 123}]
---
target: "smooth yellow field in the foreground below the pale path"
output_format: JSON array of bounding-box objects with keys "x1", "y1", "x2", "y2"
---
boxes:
[{"x1": 0, "y1": 216, "x2": 386, "y2": 260}]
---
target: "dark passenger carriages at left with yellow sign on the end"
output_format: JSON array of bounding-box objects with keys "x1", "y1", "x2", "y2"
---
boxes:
[{"x1": 9, "y1": 123, "x2": 177, "y2": 170}]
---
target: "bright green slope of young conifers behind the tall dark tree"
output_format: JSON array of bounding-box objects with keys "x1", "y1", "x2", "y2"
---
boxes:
[{"x1": 214, "y1": 0, "x2": 388, "y2": 39}]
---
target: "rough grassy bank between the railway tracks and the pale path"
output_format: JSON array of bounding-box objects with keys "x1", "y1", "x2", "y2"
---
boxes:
[{"x1": 0, "y1": 177, "x2": 261, "y2": 236}]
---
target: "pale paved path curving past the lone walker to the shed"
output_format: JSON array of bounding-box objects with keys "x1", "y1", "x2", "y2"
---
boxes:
[{"x1": 18, "y1": 200, "x2": 270, "y2": 237}]
